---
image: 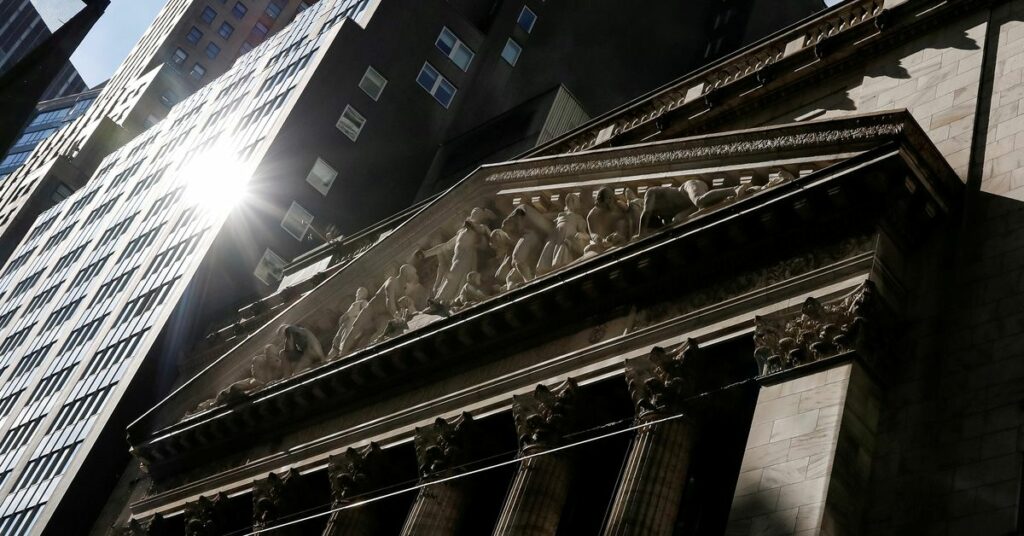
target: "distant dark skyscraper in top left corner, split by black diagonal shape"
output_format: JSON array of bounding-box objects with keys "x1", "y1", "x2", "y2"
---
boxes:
[{"x1": 0, "y1": 0, "x2": 87, "y2": 100}]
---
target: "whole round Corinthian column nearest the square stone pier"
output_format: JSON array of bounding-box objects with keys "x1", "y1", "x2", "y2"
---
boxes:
[{"x1": 603, "y1": 339, "x2": 699, "y2": 536}]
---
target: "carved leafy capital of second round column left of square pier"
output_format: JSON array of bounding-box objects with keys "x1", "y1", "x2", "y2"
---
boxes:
[{"x1": 512, "y1": 378, "x2": 578, "y2": 452}]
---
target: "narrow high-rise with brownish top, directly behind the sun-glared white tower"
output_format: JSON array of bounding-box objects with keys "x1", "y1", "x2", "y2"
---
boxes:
[{"x1": 0, "y1": 0, "x2": 323, "y2": 259}]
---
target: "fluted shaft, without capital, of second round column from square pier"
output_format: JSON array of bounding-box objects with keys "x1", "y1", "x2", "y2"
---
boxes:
[{"x1": 495, "y1": 453, "x2": 569, "y2": 536}]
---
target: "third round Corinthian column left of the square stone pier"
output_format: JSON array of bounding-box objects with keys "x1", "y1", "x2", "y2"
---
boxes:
[{"x1": 401, "y1": 413, "x2": 473, "y2": 536}]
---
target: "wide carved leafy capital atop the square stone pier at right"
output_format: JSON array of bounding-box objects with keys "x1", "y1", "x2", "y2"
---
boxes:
[{"x1": 754, "y1": 281, "x2": 885, "y2": 376}]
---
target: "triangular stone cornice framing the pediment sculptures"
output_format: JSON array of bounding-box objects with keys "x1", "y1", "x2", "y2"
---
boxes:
[{"x1": 128, "y1": 114, "x2": 959, "y2": 496}]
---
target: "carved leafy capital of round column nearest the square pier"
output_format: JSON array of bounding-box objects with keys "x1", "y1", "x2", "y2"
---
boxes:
[{"x1": 626, "y1": 339, "x2": 700, "y2": 418}]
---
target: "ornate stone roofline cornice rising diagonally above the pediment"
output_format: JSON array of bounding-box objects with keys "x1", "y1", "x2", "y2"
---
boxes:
[{"x1": 527, "y1": 0, "x2": 992, "y2": 156}]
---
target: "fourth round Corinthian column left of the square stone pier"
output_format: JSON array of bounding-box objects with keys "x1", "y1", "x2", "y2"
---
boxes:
[{"x1": 324, "y1": 443, "x2": 383, "y2": 536}]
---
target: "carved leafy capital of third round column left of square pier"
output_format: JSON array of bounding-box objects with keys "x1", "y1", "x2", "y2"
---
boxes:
[{"x1": 414, "y1": 413, "x2": 473, "y2": 480}]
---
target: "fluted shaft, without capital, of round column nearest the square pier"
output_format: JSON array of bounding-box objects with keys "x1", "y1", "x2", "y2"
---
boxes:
[{"x1": 603, "y1": 414, "x2": 696, "y2": 536}]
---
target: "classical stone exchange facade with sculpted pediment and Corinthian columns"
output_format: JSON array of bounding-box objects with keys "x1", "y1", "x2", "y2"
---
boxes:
[{"x1": 114, "y1": 0, "x2": 1024, "y2": 535}]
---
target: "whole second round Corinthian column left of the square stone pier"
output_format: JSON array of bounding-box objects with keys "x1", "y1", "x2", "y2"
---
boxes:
[{"x1": 495, "y1": 379, "x2": 577, "y2": 536}]
